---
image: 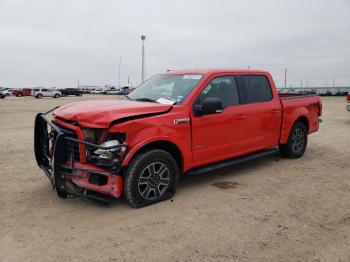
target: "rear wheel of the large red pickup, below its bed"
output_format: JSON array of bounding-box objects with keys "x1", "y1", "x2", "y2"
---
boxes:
[{"x1": 279, "y1": 122, "x2": 308, "y2": 158}]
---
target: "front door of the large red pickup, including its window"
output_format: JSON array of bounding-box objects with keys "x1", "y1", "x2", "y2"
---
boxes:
[{"x1": 191, "y1": 76, "x2": 246, "y2": 165}]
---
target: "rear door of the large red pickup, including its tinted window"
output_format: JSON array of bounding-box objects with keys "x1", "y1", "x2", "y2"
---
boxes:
[{"x1": 237, "y1": 75, "x2": 282, "y2": 150}]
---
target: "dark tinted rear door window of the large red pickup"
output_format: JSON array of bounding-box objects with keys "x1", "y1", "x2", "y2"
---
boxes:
[{"x1": 240, "y1": 75, "x2": 272, "y2": 104}]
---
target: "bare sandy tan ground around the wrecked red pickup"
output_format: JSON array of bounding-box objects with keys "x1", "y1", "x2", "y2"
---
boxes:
[{"x1": 0, "y1": 96, "x2": 350, "y2": 261}]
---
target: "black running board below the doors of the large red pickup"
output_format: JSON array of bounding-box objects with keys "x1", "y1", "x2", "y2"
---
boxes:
[{"x1": 187, "y1": 148, "x2": 278, "y2": 175}]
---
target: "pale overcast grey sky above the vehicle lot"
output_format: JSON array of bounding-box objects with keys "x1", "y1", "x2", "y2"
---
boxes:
[{"x1": 0, "y1": 0, "x2": 350, "y2": 88}]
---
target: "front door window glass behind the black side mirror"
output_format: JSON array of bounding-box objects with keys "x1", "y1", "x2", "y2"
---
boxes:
[{"x1": 195, "y1": 76, "x2": 239, "y2": 107}]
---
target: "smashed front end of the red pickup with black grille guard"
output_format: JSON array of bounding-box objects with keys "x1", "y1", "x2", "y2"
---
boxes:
[{"x1": 34, "y1": 107, "x2": 127, "y2": 202}]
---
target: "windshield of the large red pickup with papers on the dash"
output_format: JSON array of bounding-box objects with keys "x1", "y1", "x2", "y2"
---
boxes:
[{"x1": 128, "y1": 74, "x2": 202, "y2": 105}]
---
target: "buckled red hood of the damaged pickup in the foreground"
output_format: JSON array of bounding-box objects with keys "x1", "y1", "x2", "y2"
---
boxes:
[{"x1": 53, "y1": 99, "x2": 172, "y2": 128}]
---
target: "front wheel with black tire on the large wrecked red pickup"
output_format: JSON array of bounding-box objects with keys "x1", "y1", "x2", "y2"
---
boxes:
[{"x1": 124, "y1": 149, "x2": 179, "y2": 208}]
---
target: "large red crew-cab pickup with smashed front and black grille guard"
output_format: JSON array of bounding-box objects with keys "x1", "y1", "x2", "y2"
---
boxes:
[{"x1": 34, "y1": 70, "x2": 322, "y2": 207}]
